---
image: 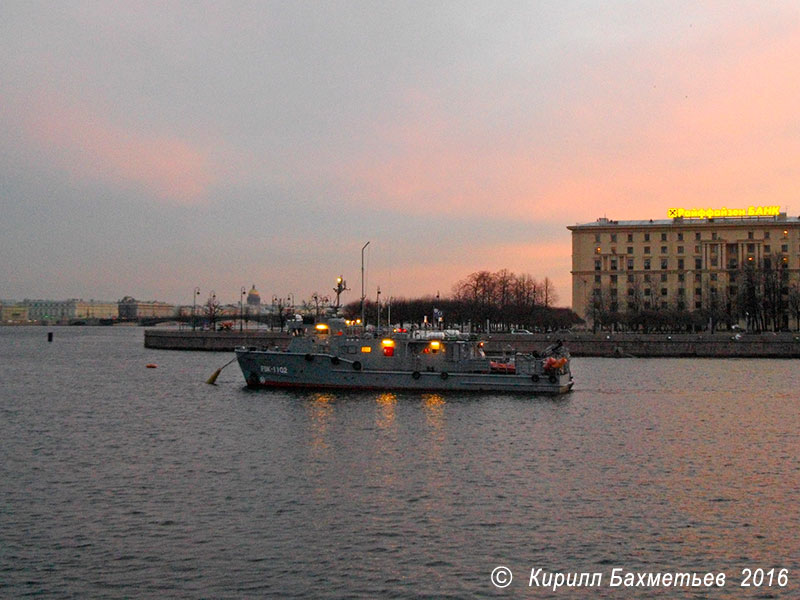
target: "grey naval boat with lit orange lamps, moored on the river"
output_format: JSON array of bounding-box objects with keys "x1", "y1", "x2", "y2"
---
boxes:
[{"x1": 236, "y1": 318, "x2": 573, "y2": 395}]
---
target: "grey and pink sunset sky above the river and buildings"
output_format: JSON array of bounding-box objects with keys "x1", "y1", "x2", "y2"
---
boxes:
[{"x1": 0, "y1": 0, "x2": 800, "y2": 305}]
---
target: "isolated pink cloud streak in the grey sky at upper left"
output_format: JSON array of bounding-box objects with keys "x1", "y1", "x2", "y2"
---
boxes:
[{"x1": 25, "y1": 94, "x2": 216, "y2": 204}]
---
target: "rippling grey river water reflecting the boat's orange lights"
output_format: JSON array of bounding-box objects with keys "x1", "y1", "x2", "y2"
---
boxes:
[{"x1": 0, "y1": 327, "x2": 800, "y2": 599}]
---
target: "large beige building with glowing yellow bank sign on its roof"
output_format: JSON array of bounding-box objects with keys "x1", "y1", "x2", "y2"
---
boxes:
[{"x1": 567, "y1": 207, "x2": 800, "y2": 322}]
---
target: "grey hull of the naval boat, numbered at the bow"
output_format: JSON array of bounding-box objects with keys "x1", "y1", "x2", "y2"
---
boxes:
[{"x1": 236, "y1": 350, "x2": 573, "y2": 395}]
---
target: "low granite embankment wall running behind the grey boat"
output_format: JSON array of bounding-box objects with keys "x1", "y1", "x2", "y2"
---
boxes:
[{"x1": 144, "y1": 329, "x2": 800, "y2": 358}]
